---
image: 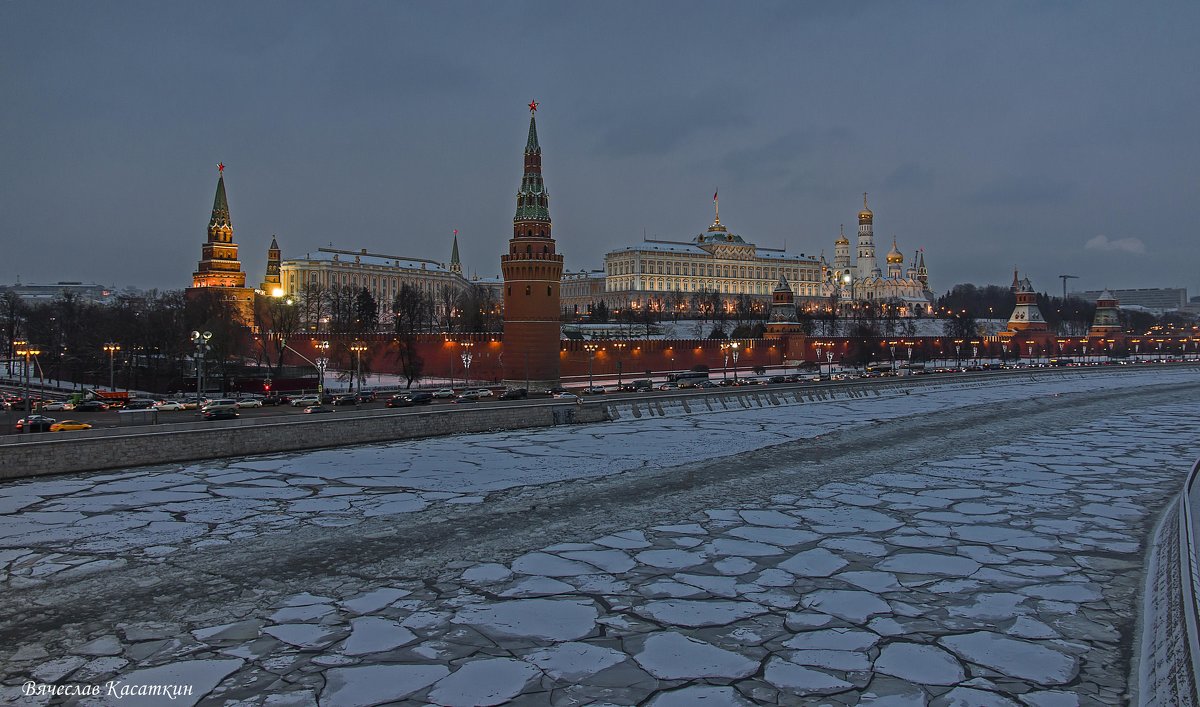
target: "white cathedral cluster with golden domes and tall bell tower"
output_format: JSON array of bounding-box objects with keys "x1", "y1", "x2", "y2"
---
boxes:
[{"x1": 821, "y1": 193, "x2": 934, "y2": 313}]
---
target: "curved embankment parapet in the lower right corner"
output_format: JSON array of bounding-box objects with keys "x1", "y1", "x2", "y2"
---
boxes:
[{"x1": 1136, "y1": 453, "x2": 1200, "y2": 707}]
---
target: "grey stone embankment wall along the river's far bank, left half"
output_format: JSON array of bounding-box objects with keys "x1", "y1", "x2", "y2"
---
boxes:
[{"x1": 0, "y1": 403, "x2": 605, "y2": 480}]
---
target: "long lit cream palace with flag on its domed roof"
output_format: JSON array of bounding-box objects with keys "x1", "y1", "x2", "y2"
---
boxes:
[{"x1": 604, "y1": 199, "x2": 822, "y2": 308}]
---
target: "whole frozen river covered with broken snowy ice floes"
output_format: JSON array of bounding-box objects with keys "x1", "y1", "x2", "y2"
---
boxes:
[{"x1": 0, "y1": 371, "x2": 1200, "y2": 706}]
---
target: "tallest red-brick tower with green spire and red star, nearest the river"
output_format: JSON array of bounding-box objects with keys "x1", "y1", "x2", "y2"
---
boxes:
[{"x1": 500, "y1": 101, "x2": 563, "y2": 390}]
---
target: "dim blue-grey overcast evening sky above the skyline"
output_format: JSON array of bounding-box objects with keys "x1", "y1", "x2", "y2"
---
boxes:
[{"x1": 0, "y1": 0, "x2": 1200, "y2": 295}]
